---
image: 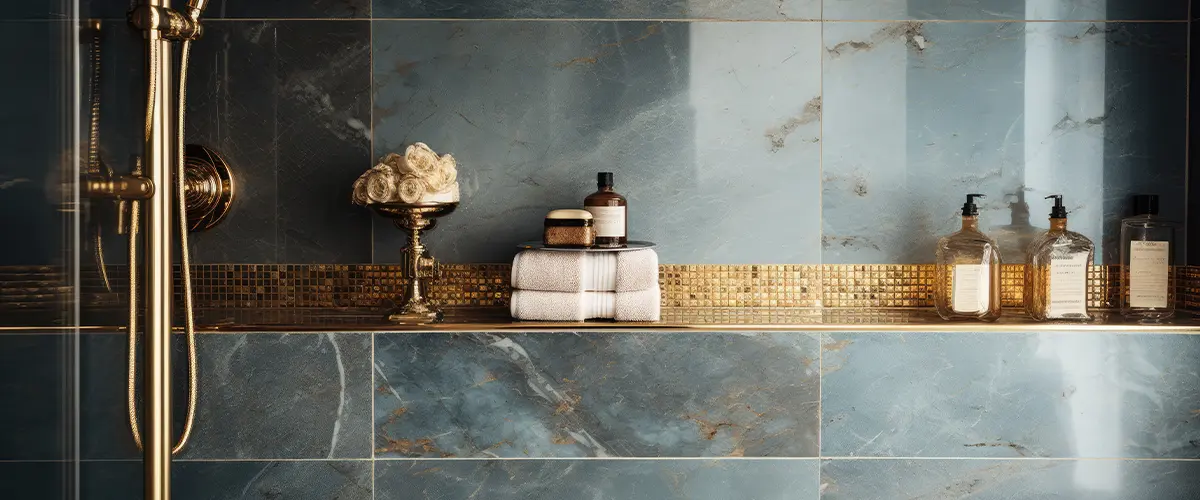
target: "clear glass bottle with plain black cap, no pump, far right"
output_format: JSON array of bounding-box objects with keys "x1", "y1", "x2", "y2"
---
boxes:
[{"x1": 1121, "y1": 194, "x2": 1175, "y2": 320}]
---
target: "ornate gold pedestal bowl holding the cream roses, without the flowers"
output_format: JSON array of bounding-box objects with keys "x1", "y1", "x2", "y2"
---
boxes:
[{"x1": 368, "y1": 203, "x2": 458, "y2": 325}]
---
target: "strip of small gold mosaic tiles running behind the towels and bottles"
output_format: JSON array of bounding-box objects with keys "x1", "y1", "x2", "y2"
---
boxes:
[{"x1": 0, "y1": 264, "x2": 1180, "y2": 311}]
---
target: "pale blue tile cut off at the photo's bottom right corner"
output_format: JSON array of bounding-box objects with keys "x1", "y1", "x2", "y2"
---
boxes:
[{"x1": 821, "y1": 460, "x2": 1200, "y2": 500}]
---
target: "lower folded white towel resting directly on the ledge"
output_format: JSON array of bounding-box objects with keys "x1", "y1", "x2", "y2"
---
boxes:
[{"x1": 510, "y1": 287, "x2": 661, "y2": 321}]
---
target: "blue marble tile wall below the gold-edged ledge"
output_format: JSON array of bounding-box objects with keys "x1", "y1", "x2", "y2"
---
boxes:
[{"x1": 0, "y1": 331, "x2": 1200, "y2": 500}]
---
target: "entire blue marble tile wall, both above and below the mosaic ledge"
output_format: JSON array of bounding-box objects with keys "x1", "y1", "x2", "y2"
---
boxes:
[{"x1": 0, "y1": 0, "x2": 1200, "y2": 500}]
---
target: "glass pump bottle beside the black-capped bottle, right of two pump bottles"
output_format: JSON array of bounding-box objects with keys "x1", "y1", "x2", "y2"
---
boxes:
[{"x1": 1024, "y1": 194, "x2": 1096, "y2": 321}]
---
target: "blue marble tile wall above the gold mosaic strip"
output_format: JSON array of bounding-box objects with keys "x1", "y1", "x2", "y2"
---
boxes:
[{"x1": 0, "y1": 0, "x2": 1189, "y2": 264}]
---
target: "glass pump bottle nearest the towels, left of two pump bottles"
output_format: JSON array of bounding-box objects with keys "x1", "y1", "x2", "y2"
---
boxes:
[{"x1": 934, "y1": 194, "x2": 1001, "y2": 321}]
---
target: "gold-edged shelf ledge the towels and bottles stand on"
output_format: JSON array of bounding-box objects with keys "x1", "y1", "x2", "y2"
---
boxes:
[{"x1": 9, "y1": 308, "x2": 1200, "y2": 335}]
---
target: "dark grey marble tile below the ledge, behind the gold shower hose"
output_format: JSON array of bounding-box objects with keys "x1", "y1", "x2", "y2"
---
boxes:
[{"x1": 82, "y1": 333, "x2": 371, "y2": 459}]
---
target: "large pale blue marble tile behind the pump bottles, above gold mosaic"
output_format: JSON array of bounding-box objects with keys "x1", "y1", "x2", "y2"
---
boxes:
[{"x1": 822, "y1": 23, "x2": 1187, "y2": 264}]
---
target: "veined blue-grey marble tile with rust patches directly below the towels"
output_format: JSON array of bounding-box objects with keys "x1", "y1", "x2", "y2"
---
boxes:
[{"x1": 374, "y1": 332, "x2": 817, "y2": 457}]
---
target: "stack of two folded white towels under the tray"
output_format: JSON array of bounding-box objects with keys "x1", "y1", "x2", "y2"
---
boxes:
[{"x1": 512, "y1": 248, "x2": 661, "y2": 321}]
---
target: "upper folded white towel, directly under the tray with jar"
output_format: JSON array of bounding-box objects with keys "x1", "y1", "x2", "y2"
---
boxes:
[{"x1": 512, "y1": 248, "x2": 659, "y2": 291}]
